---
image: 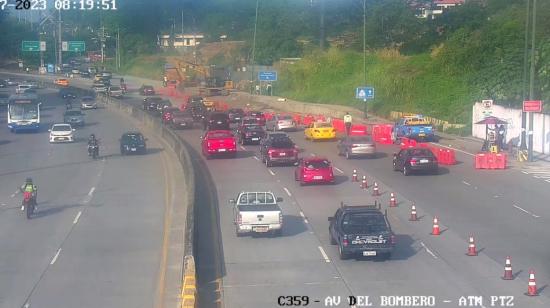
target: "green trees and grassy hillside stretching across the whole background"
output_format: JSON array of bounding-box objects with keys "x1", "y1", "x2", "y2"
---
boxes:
[{"x1": 0, "y1": 0, "x2": 550, "y2": 122}]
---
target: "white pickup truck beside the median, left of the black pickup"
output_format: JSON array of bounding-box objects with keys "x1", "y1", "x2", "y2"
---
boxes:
[{"x1": 229, "y1": 192, "x2": 283, "y2": 236}]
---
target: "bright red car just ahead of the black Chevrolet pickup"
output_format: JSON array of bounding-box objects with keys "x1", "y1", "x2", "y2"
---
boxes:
[{"x1": 294, "y1": 157, "x2": 334, "y2": 186}]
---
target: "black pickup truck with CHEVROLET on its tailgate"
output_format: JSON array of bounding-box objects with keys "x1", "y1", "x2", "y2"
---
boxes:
[{"x1": 328, "y1": 202, "x2": 395, "y2": 260}]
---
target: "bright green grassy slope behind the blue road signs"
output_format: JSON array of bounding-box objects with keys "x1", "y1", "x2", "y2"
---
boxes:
[{"x1": 278, "y1": 49, "x2": 476, "y2": 123}]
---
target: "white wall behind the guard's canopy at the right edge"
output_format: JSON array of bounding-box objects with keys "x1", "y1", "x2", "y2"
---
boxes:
[{"x1": 472, "y1": 102, "x2": 550, "y2": 154}]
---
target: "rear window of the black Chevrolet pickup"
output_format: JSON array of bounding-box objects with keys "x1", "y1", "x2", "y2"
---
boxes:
[{"x1": 342, "y1": 213, "x2": 388, "y2": 234}]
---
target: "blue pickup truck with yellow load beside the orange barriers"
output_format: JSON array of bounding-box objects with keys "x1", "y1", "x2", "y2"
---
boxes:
[{"x1": 393, "y1": 115, "x2": 434, "y2": 142}]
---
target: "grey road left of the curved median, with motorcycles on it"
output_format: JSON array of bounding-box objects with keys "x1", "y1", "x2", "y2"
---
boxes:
[{"x1": 0, "y1": 76, "x2": 170, "y2": 308}]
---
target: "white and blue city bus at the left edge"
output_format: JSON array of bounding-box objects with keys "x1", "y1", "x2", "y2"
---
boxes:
[{"x1": 8, "y1": 93, "x2": 41, "y2": 133}]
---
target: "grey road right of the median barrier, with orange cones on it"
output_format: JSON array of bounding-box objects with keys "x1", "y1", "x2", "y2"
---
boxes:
[{"x1": 113, "y1": 82, "x2": 550, "y2": 307}]
